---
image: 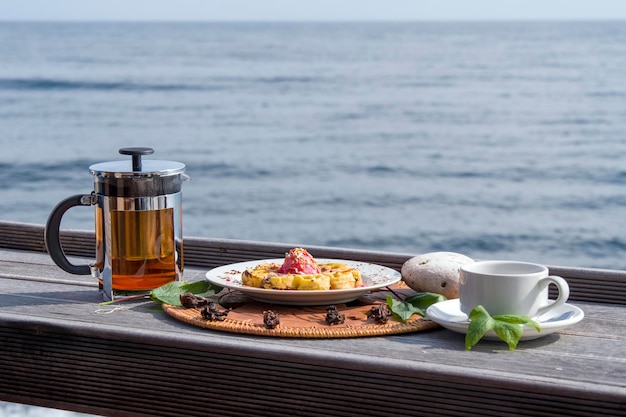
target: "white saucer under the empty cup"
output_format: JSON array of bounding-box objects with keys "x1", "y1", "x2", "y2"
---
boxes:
[{"x1": 426, "y1": 298, "x2": 585, "y2": 340}]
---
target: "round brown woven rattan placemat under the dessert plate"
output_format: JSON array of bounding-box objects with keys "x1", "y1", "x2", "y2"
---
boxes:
[{"x1": 163, "y1": 282, "x2": 438, "y2": 338}]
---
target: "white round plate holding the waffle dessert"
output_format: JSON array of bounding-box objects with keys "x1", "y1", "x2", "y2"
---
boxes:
[{"x1": 206, "y1": 258, "x2": 402, "y2": 306}]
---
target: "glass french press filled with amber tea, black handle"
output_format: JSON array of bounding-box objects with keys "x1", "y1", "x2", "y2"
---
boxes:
[{"x1": 45, "y1": 148, "x2": 189, "y2": 300}]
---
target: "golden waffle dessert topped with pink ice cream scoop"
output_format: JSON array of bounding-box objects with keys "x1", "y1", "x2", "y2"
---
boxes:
[{"x1": 241, "y1": 248, "x2": 363, "y2": 290}]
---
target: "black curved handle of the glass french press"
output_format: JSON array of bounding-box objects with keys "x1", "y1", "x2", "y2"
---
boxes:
[{"x1": 44, "y1": 194, "x2": 96, "y2": 275}]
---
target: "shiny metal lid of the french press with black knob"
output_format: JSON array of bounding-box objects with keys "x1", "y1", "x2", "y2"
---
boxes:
[{"x1": 89, "y1": 148, "x2": 188, "y2": 197}]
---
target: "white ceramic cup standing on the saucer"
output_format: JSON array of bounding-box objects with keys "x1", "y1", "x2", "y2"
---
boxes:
[{"x1": 459, "y1": 261, "x2": 569, "y2": 317}]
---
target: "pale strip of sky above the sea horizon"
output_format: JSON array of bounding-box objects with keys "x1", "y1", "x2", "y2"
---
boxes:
[{"x1": 0, "y1": 0, "x2": 626, "y2": 21}]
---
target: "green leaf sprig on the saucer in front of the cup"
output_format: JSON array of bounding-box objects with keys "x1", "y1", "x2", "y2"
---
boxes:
[{"x1": 465, "y1": 305, "x2": 541, "y2": 350}]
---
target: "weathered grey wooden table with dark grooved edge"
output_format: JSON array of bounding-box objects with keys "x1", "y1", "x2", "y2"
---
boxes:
[{"x1": 0, "y1": 222, "x2": 626, "y2": 416}]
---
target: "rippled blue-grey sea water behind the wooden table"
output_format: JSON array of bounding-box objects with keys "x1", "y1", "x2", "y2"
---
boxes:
[{"x1": 0, "y1": 22, "x2": 626, "y2": 269}]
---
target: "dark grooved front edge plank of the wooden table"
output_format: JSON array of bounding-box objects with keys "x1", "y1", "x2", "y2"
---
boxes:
[{"x1": 0, "y1": 314, "x2": 626, "y2": 416}]
